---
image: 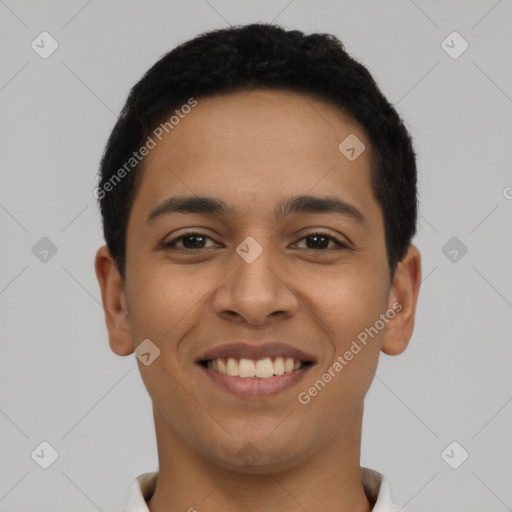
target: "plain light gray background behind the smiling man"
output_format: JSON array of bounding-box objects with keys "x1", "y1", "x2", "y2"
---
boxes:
[{"x1": 0, "y1": 0, "x2": 512, "y2": 512}]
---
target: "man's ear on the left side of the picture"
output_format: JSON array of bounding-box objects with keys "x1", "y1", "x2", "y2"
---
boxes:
[{"x1": 94, "y1": 245, "x2": 134, "y2": 356}]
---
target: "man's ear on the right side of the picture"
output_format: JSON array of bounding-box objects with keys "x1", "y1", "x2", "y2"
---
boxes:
[{"x1": 382, "y1": 245, "x2": 421, "y2": 356}]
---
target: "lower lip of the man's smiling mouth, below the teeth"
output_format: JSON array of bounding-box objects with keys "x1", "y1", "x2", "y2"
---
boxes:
[{"x1": 198, "y1": 364, "x2": 313, "y2": 399}]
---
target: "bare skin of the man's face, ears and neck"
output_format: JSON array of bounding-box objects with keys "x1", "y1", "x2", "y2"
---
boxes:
[{"x1": 95, "y1": 90, "x2": 421, "y2": 512}]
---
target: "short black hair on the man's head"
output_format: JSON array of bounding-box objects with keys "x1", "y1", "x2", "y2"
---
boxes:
[{"x1": 95, "y1": 23, "x2": 418, "y2": 281}]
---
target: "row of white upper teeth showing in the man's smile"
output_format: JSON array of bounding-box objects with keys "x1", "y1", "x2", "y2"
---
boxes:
[{"x1": 207, "y1": 357, "x2": 301, "y2": 379}]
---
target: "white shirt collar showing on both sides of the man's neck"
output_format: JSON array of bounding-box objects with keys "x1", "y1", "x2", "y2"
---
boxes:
[{"x1": 123, "y1": 468, "x2": 407, "y2": 512}]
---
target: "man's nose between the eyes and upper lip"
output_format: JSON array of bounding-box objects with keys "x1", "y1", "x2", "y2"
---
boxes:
[{"x1": 213, "y1": 239, "x2": 299, "y2": 326}]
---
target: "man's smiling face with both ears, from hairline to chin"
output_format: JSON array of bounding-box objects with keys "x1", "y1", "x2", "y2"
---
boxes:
[{"x1": 96, "y1": 90, "x2": 419, "y2": 472}]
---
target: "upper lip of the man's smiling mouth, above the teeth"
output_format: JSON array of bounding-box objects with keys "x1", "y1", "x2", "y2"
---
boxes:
[{"x1": 196, "y1": 341, "x2": 315, "y2": 363}]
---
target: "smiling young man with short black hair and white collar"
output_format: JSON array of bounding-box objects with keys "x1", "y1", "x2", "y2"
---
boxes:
[{"x1": 95, "y1": 24, "x2": 421, "y2": 512}]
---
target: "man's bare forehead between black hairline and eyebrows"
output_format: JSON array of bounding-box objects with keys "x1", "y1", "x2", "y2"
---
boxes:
[{"x1": 128, "y1": 90, "x2": 378, "y2": 229}]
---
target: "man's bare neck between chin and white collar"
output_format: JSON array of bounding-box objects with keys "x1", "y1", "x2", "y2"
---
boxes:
[{"x1": 148, "y1": 407, "x2": 372, "y2": 512}]
